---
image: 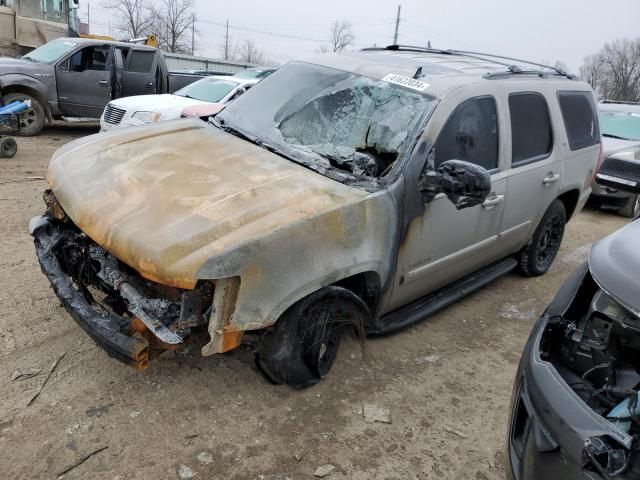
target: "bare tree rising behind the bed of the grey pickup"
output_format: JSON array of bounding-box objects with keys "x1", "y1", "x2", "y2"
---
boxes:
[{"x1": 153, "y1": 0, "x2": 197, "y2": 53}]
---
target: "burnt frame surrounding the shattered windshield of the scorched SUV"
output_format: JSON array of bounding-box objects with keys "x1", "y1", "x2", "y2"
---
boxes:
[{"x1": 212, "y1": 60, "x2": 440, "y2": 191}]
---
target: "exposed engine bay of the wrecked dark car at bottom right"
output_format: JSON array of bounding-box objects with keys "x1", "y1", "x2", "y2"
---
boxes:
[{"x1": 540, "y1": 273, "x2": 640, "y2": 478}]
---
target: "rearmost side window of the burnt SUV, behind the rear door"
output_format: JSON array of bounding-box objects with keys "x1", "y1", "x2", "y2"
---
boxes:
[{"x1": 558, "y1": 92, "x2": 600, "y2": 150}]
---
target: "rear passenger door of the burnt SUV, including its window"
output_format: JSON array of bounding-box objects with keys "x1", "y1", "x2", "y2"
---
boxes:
[{"x1": 500, "y1": 90, "x2": 562, "y2": 253}]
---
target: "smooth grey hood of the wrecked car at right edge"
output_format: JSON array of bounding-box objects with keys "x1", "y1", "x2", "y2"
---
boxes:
[{"x1": 589, "y1": 220, "x2": 640, "y2": 312}]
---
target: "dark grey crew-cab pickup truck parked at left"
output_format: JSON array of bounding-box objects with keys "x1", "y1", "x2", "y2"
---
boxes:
[{"x1": 0, "y1": 38, "x2": 204, "y2": 136}]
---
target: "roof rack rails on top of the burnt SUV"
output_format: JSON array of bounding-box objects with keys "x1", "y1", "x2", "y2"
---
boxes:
[{"x1": 363, "y1": 44, "x2": 576, "y2": 80}]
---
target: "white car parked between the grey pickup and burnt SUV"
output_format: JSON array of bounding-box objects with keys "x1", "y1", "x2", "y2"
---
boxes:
[{"x1": 100, "y1": 76, "x2": 260, "y2": 131}]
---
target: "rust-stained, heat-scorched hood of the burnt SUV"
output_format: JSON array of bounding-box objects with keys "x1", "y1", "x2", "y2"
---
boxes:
[{"x1": 47, "y1": 119, "x2": 367, "y2": 288}]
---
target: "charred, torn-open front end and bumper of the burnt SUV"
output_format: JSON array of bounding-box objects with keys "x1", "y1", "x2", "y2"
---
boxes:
[{"x1": 29, "y1": 191, "x2": 214, "y2": 370}]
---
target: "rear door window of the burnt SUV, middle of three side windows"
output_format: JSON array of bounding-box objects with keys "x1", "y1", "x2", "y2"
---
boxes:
[{"x1": 509, "y1": 93, "x2": 553, "y2": 166}]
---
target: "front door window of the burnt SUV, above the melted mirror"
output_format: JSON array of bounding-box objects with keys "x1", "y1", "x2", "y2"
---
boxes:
[{"x1": 435, "y1": 97, "x2": 498, "y2": 170}]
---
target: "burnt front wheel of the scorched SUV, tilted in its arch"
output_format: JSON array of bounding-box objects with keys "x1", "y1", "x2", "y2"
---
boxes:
[{"x1": 256, "y1": 287, "x2": 370, "y2": 389}]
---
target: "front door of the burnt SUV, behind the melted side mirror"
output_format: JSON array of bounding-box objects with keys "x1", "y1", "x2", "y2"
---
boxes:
[{"x1": 385, "y1": 94, "x2": 506, "y2": 311}]
